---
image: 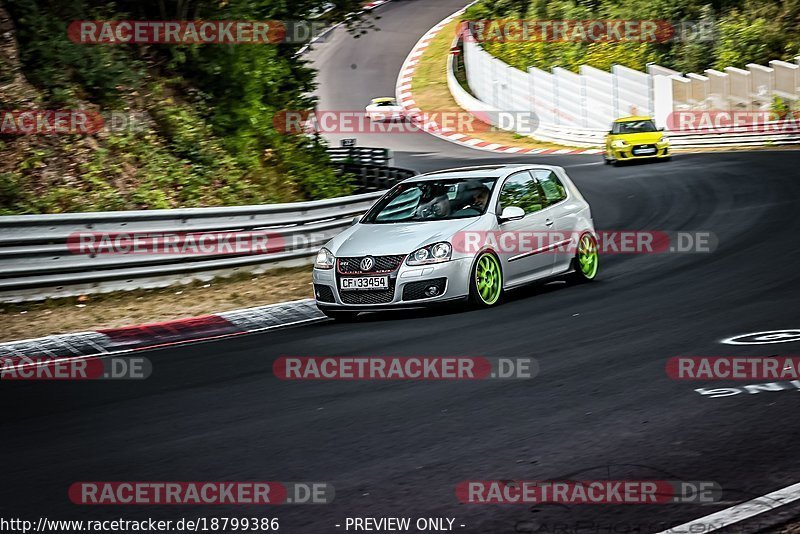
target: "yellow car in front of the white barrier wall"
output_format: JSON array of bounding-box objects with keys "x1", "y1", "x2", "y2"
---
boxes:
[{"x1": 603, "y1": 117, "x2": 670, "y2": 165}]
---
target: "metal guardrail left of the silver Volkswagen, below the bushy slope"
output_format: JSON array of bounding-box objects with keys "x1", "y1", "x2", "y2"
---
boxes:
[{"x1": 0, "y1": 157, "x2": 416, "y2": 302}]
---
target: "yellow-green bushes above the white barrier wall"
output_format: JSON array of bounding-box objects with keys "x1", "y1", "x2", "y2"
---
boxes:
[{"x1": 462, "y1": 0, "x2": 800, "y2": 72}]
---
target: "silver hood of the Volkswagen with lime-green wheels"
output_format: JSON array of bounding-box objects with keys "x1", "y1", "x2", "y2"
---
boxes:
[{"x1": 325, "y1": 219, "x2": 486, "y2": 257}]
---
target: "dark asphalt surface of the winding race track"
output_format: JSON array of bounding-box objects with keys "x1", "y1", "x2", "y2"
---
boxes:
[{"x1": 0, "y1": 0, "x2": 800, "y2": 533}]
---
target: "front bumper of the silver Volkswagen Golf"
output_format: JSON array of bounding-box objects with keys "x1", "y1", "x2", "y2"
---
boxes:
[{"x1": 312, "y1": 258, "x2": 472, "y2": 311}]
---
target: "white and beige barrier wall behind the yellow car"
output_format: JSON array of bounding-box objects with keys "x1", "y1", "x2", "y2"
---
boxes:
[{"x1": 463, "y1": 39, "x2": 800, "y2": 130}]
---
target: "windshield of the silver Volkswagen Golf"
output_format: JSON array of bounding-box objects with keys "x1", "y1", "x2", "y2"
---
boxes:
[{"x1": 361, "y1": 178, "x2": 497, "y2": 224}]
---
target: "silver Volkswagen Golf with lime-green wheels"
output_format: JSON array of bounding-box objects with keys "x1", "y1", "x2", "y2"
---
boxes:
[{"x1": 313, "y1": 165, "x2": 598, "y2": 319}]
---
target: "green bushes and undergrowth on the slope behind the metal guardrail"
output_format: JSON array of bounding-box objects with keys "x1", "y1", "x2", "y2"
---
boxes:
[{"x1": 0, "y1": 0, "x2": 363, "y2": 213}]
